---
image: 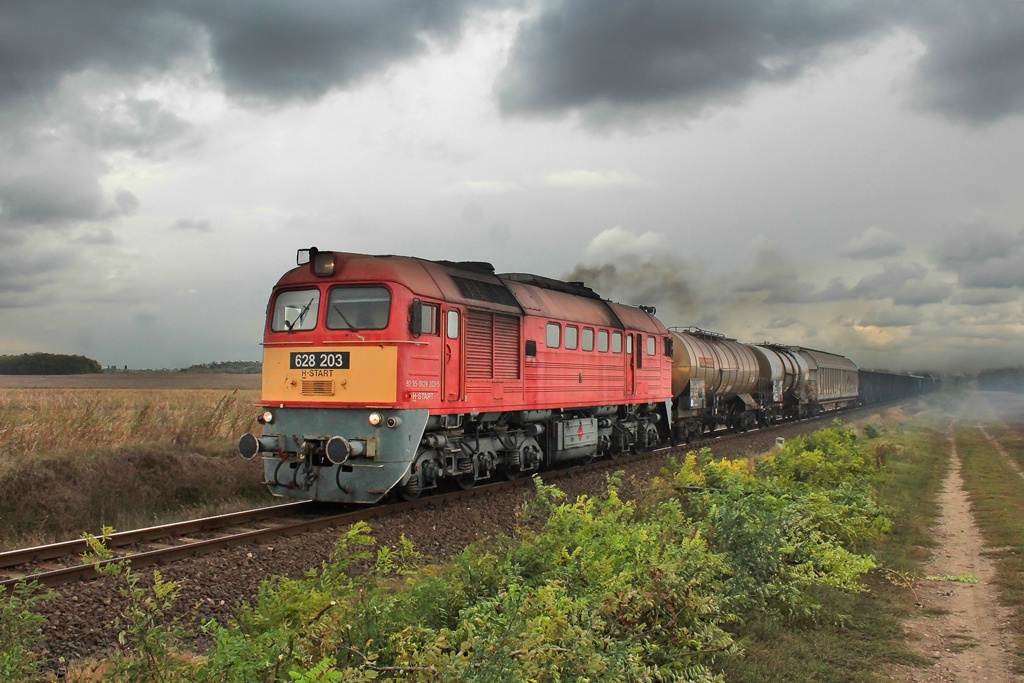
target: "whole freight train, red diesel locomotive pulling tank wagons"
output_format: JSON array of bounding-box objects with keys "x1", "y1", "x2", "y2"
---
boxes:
[{"x1": 239, "y1": 248, "x2": 931, "y2": 504}]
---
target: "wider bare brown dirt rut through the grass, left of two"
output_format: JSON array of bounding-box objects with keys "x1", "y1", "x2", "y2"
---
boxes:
[{"x1": 892, "y1": 430, "x2": 1024, "y2": 683}]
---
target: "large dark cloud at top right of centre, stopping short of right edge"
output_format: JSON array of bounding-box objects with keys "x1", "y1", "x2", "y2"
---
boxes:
[{"x1": 498, "y1": 0, "x2": 884, "y2": 118}]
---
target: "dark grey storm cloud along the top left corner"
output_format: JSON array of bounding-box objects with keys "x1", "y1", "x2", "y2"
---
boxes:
[{"x1": 0, "y1": 0, "x2": 512, "y2": 103}]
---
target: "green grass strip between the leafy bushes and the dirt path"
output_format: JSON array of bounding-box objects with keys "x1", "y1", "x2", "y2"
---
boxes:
[{"x1": 723, "y1": 409, "x2": 948, "y2": 683}]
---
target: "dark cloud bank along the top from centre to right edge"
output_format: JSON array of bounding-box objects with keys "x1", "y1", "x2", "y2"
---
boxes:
[{"x1": 497, "y1": 0, "x2": 1024, "y2": 123}]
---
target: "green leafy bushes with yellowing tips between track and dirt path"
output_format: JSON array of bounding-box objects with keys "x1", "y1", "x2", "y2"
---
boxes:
[{"x1": 25, "y1": 425, "x2": 889, "y2": 683}]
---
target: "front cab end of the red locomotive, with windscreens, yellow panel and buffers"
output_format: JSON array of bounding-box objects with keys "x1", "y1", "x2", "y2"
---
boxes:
[{"x1": 239, "y1": 249, "x2": 440, "y2": 503}]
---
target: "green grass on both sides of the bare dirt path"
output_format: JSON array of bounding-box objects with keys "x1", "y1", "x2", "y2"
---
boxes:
[{"x1": 723, "y1": 393, "x2": 1024, "y2": 683}]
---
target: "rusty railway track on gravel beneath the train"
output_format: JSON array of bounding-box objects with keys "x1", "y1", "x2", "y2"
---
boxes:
[{"x1": 0, "y1": 405, "x2": 879, "y2": 588}]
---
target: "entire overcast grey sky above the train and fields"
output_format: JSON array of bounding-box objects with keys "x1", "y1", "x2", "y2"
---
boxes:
[{"x1": 0, "y1": 0, "x2": 1024, "y2": 371}]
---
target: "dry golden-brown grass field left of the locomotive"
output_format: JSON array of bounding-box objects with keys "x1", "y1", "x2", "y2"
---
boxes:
[{"x1": 0, "y1": 373, "x2": 269, "y2": 548}]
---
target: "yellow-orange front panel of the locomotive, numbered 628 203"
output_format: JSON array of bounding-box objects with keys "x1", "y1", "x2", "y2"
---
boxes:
[{"x1": 263, "y1": 346, "x2": 398, "y2": 405}]
